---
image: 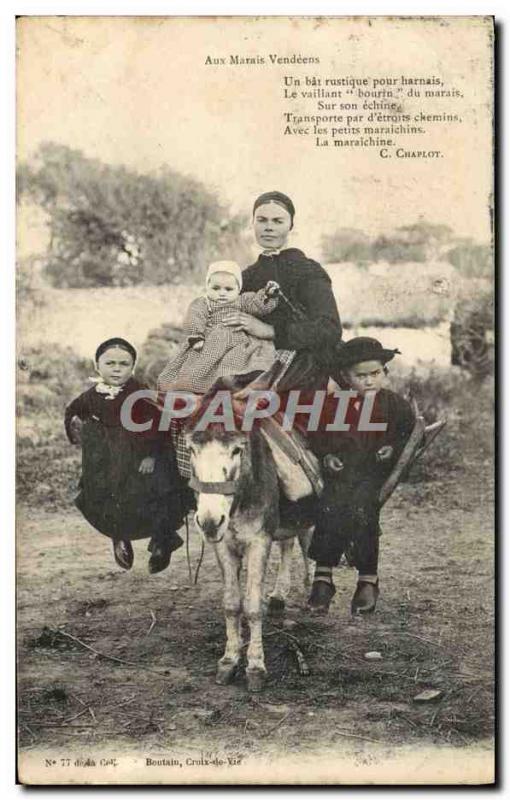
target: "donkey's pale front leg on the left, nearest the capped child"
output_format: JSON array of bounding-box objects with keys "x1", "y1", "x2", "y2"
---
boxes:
[{"x1": 215, "y1": 542, "x2": 242, "y2": 685}]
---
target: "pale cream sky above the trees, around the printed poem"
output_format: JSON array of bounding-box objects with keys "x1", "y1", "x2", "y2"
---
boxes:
[{"x1": 17, "y1": 17, "x2": 492, "y2": 255}]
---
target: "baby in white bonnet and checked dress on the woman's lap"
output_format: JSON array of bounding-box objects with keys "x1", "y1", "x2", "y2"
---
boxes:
[{"x1": 158, "y1": 261, "x2": 279, "y2": 394}]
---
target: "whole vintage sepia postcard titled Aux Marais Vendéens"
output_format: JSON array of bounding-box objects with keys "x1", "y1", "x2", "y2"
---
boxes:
[{"x1": 17, "y1": 16, "x2": 495, "y2": 785}]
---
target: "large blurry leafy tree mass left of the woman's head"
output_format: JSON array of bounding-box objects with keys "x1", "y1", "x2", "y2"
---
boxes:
[{"x1": 17, "y1": 143, "x2": 244, "y2": 286}]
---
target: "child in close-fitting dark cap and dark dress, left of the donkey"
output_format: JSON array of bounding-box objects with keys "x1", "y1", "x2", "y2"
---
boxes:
[{"x1": 65, "y1": 337, "x2": 183, "y2": 573}]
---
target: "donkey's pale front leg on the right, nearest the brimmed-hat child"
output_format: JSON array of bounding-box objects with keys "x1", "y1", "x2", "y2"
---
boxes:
[{"x1": 244, "y1": 532, "x2": 271, "y2": 692}]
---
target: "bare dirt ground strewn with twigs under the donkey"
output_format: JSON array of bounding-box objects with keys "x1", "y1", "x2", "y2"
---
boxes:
[{"x1": 18, "y1": 400, "x2": 494, "y2": 776}]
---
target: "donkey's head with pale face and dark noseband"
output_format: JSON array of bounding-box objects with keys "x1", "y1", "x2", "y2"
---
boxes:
[{"x1": 186, "y1": 425, "x2": 249, "y2": 543}]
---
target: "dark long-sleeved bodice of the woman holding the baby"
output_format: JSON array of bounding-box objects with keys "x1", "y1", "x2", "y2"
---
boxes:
[{"x1": 243, "y1": 247, "x2": 342, "y2": 389}]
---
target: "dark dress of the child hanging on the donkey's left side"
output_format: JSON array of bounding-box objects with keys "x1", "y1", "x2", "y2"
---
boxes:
[{"x1": 65, "y1": 378, "x2": 183, "y2": 539}]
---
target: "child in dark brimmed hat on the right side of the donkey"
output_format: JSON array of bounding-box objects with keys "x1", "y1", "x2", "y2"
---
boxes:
[{"x1": 308, "y1": 336, "x2": 415, "y2": 614}]
